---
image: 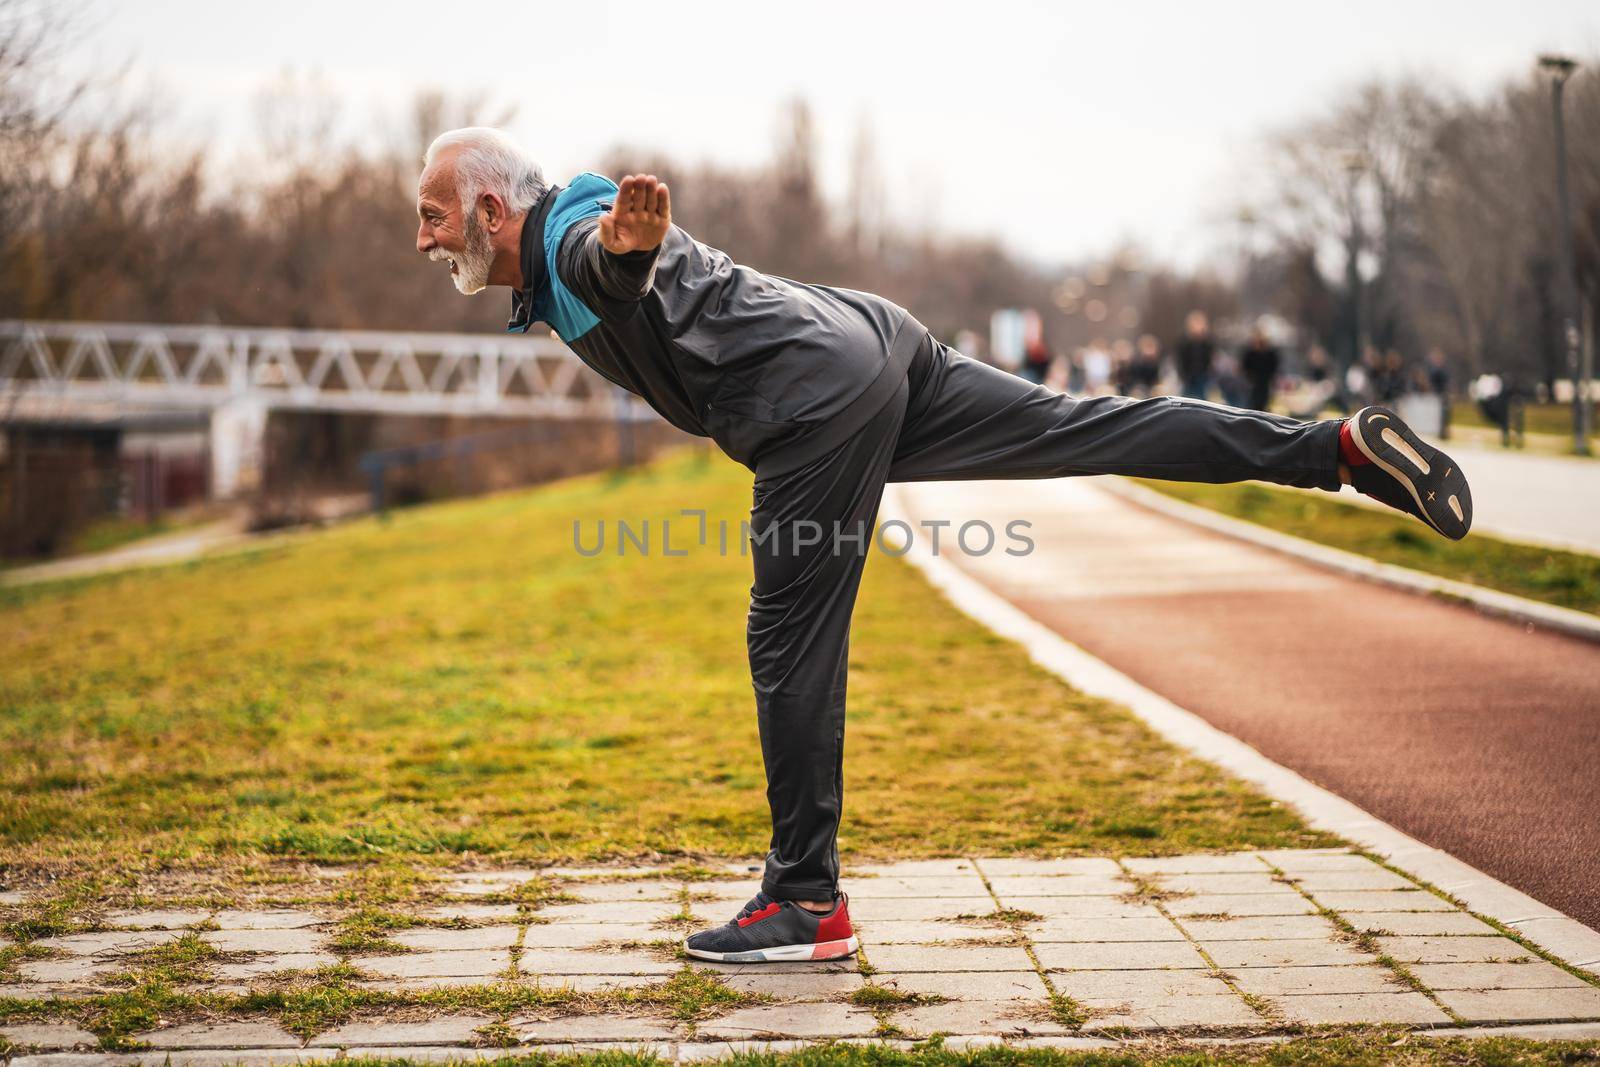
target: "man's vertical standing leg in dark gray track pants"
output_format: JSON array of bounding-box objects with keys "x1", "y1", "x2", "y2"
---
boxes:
[{"x1": 749, "y1": 375, "x2": 909, "y2": 901}]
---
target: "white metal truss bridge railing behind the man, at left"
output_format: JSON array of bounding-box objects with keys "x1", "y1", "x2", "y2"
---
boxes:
[{"x1": 0, "y1": 320, "x2": 632, "y2": 418}]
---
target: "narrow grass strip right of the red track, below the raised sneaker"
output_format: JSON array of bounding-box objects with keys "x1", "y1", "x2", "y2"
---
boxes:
[{"x1": 1142, "y1": 482, "x2": 1600, "y2": 613}]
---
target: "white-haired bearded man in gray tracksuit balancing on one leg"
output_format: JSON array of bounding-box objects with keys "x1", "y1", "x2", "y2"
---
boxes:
[{"x1": 416, "y1": 126, "x2": 1472, "y2": 963}]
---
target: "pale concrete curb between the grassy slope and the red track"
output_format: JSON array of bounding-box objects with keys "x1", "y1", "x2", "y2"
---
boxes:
[{"x1": 883, "y1": 485, "x2": 1600, "y2": 974}]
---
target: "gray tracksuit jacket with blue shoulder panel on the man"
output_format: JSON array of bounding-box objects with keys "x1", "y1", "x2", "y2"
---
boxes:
[{"x1": 507, "y1": 174, "x2": 928, "y2": 477}]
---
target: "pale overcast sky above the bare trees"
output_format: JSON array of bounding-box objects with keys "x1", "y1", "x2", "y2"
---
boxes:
[{"x1": 74, "y1": 0, "x2": 1600, "y2": 262}]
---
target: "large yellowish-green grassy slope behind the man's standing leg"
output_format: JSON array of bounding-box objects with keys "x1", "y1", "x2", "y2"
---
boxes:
[{"x1": 0, "y1": 458, "x2": 1326, "y2": 872}]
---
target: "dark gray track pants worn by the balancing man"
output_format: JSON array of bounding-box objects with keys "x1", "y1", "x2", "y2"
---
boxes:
[{"x1": 749, "y1": 338, "x2": 1339, "y2": 901}]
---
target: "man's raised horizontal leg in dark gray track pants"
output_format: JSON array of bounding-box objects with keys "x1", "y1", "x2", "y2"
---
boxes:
[{"x1": 890, "y1": 341, "x2": 1339, "y2": 491}]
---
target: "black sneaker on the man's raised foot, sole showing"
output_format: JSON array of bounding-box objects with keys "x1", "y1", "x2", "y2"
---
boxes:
[{"x1": 1350, "y1": 406, "x2": 1472, "y2": 541}]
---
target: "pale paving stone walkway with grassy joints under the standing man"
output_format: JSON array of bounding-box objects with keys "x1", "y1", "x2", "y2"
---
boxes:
[{"x1": 0, "y1": 849, "x2": 1600, "y2": 1067}]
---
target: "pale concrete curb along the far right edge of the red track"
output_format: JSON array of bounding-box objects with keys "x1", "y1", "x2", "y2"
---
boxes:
[{"x1": 1101, "y1": 478, "x2": 1600, "y2": 641}]
